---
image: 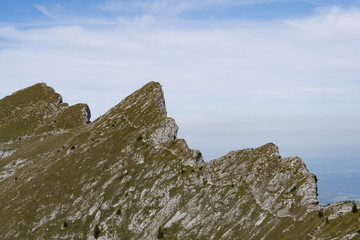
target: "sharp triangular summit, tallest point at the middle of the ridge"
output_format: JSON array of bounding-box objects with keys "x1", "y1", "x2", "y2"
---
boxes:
[{"x1": 93, "y1": 82, "x2": 178, "y2": 146}]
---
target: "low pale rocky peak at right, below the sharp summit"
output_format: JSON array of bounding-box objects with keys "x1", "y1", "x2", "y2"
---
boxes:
[{"x1": 206, "y1": 143, "x2": 318, "y2": 219}]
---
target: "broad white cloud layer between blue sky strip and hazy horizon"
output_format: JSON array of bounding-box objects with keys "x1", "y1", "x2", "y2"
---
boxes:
[{"x1": 0, "y1": 6, "x2": 360, "y2": 161}]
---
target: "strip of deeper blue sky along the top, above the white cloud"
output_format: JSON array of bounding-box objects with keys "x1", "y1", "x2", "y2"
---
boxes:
[{"x1": 0, "y1": 0, "x2": 359, "y2": 25}]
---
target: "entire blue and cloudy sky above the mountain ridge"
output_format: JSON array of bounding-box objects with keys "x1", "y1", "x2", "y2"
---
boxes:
[{"x1": 0, "y1": 0, "x2": 360, "y2": 202}]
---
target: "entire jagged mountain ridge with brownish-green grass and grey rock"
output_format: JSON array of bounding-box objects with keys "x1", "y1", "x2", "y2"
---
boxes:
[{"x1": 0, "y1": 82, "x2": 360, "y2": 239}]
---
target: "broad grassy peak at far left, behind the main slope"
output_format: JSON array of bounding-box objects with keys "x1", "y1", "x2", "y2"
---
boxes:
[{"x1": 0, "y1": 83, "x2": 91, "y2": 159}]
